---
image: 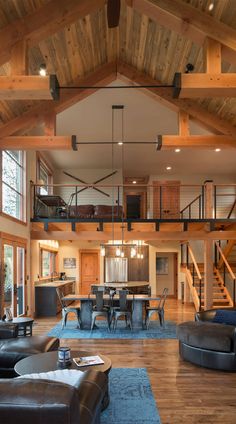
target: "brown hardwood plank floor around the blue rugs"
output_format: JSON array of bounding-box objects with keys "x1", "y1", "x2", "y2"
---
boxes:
[{"x1": 34, "y1": 299, "x2": 236, "y2": 424}]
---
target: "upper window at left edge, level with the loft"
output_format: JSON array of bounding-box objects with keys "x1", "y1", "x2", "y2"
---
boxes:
[{"x1": 2, "y1": 150, "x2": 25, "y2": 221}]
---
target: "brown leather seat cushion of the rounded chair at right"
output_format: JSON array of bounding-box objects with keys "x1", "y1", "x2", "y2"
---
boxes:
[{"x1": 176, "y1": 321, "x2": 235, "y2": 352}]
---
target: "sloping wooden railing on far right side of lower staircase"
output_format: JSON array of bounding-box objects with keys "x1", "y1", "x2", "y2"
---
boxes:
[{"x1": 215, "y1": 242, "x2": 236, "y2": 306}]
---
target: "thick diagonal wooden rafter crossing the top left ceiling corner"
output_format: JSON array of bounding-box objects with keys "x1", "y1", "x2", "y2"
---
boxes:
[{"x1": 0, "y1": 0, "x2": 105, "y2": 65}]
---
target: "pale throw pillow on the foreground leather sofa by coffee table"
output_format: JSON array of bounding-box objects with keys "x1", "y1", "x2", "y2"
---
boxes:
[{"x1": 17, "y1": 369, "x2": 83, "y2": 386}]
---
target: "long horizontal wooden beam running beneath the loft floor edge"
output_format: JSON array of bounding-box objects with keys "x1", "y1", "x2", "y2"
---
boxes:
[{"x1": 31, "y1": 230, "x2": 236, "y2": 241}]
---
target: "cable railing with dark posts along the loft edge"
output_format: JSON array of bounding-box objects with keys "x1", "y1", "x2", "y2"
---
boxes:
[{"x1": 31, "y1": 182, "x2": 236, "y2": 222}]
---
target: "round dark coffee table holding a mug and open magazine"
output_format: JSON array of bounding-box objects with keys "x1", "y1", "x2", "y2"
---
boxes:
[{"x1": 14, "y1": 350, "x2": 112, "y2": 410}]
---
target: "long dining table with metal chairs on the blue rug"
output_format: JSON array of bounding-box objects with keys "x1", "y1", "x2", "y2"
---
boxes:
[{"x1": 63, "y1": 294, "x2": 160, "y2": 330}]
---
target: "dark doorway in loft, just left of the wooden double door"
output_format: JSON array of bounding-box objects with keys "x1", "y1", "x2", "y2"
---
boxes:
[{"x1": 124, "y1": 192, "x2": 146, "y2": 219}]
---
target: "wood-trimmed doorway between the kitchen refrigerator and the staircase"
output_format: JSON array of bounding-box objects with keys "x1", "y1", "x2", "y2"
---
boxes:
[{"x1": 156, "y1": 252, "x2": 178, "y2": 299}]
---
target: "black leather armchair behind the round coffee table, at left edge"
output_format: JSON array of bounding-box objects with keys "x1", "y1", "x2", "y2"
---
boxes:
[{"x1": 0, "y1": 336, "x2": 59, "y2": 368}]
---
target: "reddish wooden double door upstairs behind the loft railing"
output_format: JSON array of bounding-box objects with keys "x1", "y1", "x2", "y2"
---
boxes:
[{"x1": 153, "y1": 181, "x2": 180, "y2": 219}]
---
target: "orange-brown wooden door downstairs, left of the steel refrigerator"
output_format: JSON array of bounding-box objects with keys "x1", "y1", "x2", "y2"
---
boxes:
[{"x1": 80, "y1": 250, "x2": 100, "y2": 294}]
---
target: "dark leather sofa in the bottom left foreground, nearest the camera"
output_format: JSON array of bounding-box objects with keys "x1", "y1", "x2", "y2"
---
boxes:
[{"x1": 0, "y1": 370, "x2": 107, "y2": 424}]
